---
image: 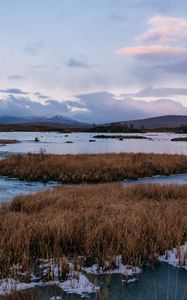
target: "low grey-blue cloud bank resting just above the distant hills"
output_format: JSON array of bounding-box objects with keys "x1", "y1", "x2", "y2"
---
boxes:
[{"x1": 0, "y1": 87, "x2": 187, "y2": 123}]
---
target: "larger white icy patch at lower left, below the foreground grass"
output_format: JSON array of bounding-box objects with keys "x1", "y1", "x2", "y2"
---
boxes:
[{"x1": 0, "y1": 256, "x2": 142, "y2": 297}]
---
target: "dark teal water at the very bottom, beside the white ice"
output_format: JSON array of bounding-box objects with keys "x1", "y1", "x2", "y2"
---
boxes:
[{"x1": 12, "y1": 263, "x2": 187, "y2": 300}]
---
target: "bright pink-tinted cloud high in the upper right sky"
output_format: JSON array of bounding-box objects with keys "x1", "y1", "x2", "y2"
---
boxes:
[{"x1": 116, "y1": 15, "x2": 187, "y2": 61}]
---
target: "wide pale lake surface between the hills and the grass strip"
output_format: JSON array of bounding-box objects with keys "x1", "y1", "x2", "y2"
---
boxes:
[{"x1": 0, "y1": 132, "x2": 187, "y2": 157}]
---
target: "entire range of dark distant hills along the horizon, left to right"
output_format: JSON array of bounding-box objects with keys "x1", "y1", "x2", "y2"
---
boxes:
[{"x1": 0, "y1": 115, "x2": 187, "y2": 133}]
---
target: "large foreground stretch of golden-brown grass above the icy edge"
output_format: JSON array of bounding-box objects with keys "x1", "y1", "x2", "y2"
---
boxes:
[{"x1": 0, "y1": 184, "x2": 187, "y2": 277}]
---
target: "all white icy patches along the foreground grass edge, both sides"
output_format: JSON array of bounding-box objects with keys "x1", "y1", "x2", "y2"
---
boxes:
[{"x1": 0, "y1": 242, "x2": 187, "y2": 298}]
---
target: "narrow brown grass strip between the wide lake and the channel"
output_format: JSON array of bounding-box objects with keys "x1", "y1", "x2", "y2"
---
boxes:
[{"x1": 0, "y1": 153, "x2": 187, "y2": 184}]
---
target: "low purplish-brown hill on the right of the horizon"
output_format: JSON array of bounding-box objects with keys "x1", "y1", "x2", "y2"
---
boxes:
[{"x1": 110, "y1": 115, "x2": 187, "y2": 129}]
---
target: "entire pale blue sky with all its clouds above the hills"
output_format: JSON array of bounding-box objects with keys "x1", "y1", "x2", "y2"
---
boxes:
[{"x1": 0, "y1": 0, "x2": 187, "y2": 122}]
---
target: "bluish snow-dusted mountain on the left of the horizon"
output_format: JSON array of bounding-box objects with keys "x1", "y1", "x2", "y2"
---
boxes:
[{"x1": 0, "y1": 115, "x2": 86, "y2": 126}]
